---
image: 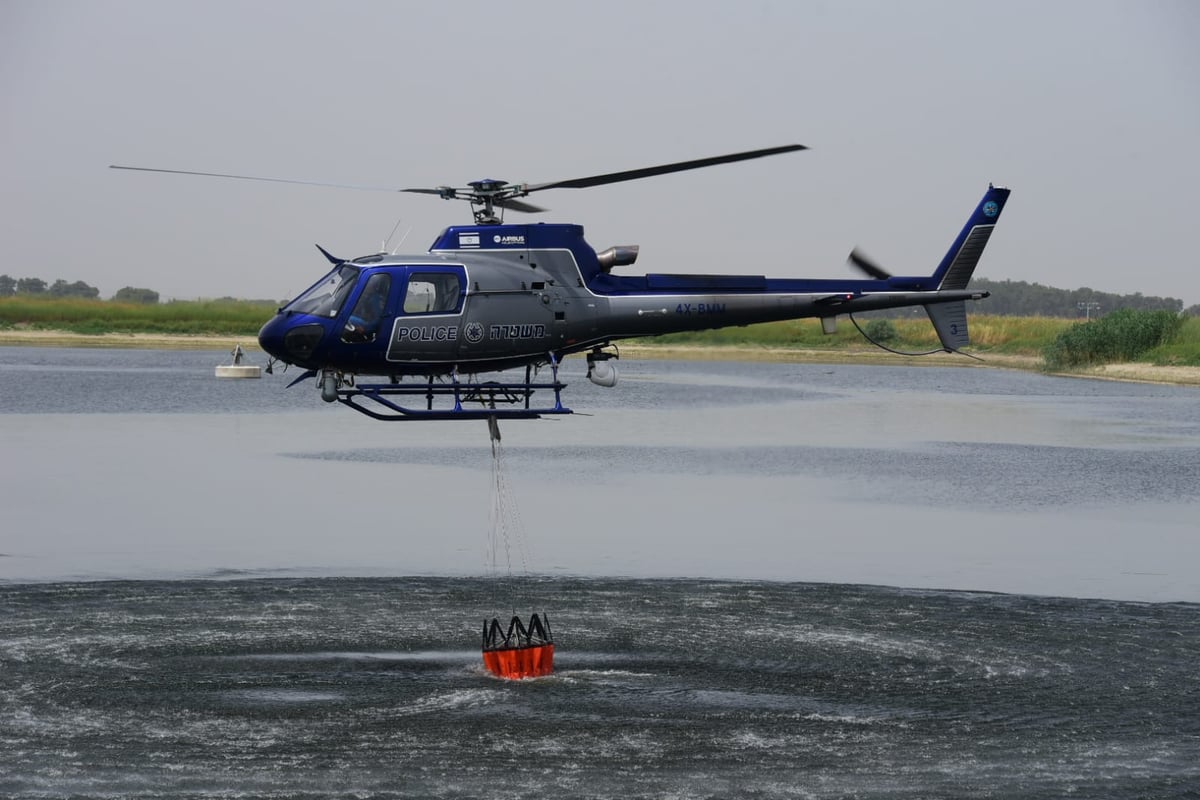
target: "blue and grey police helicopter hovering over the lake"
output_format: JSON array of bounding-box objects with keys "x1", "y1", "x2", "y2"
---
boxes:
[{"x1": 110, "y1": 144, "x2": 1009, "y2": 426}]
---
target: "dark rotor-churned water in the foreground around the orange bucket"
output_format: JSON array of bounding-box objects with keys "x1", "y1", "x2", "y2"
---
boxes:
[{"x1": 0, "y1": 578, "x2": 1200, "y2": 799}]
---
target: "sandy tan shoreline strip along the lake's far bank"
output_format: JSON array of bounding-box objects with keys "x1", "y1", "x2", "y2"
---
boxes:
[{"x1": 0, "y1": 329, "x2": 1200, "y2": 386}]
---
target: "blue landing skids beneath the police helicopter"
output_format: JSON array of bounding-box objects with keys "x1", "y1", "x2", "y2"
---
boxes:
[{"x1": 328, "y1": 365, "x2": 574, "y2": 422}]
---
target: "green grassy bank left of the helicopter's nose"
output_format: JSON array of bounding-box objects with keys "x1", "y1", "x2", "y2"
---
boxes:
[{"x1": 0, "y1": 295, "x2": 275, "y2": 336}]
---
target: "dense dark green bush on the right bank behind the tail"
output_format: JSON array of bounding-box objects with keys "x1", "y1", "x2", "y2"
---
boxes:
[{"x1": 1043, "y1": 308, "x2": 1189, "y2": 369}]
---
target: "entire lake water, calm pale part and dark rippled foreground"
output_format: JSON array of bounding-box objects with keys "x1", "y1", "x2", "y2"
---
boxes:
[{"x1": 0, "y1": 348, "x2": 1200, "y2": 798}]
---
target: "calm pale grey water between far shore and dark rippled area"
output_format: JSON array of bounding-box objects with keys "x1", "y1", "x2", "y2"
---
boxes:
[{"x1": 0, "y1": 348, "x2": 1200, "y2": 601}]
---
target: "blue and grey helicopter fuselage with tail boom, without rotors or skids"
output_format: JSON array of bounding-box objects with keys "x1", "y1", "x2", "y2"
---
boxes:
[{"x1": 259, "y1": 208, "x2": 990, "y2": 379}]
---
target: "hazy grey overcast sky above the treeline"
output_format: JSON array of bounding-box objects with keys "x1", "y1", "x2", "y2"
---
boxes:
[{"x1": 0, "y1": 0, "x2": 1200, "y2": 306}]
